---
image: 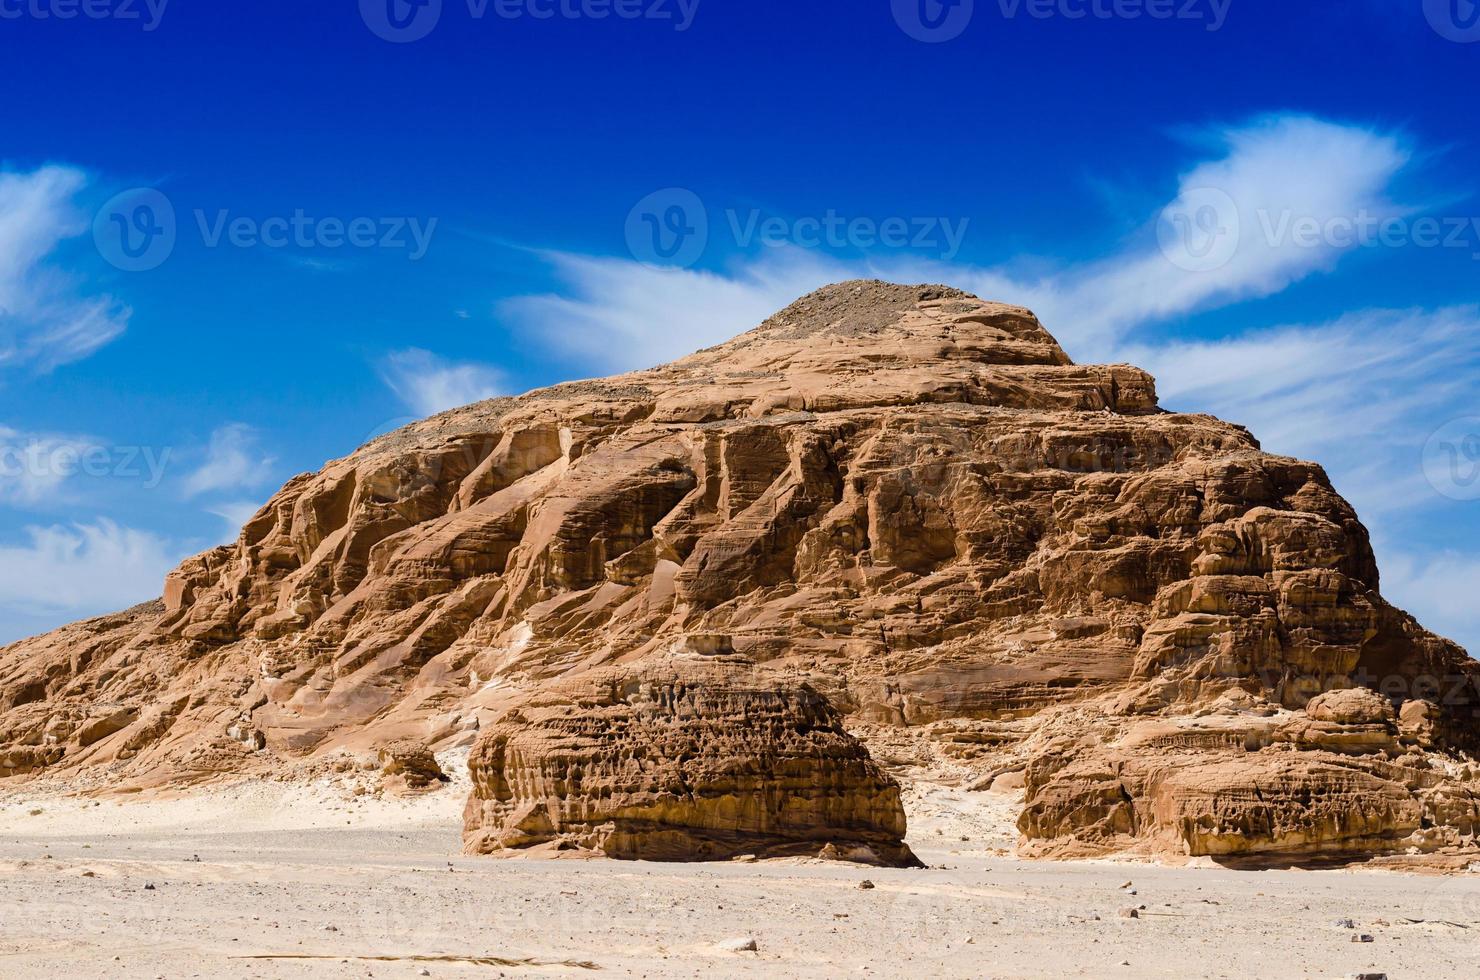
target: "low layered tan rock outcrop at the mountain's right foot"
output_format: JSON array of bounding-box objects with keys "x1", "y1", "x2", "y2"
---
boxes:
[{"x1": 1018, "y1": 690, "x2": 1480, "y2": 857}]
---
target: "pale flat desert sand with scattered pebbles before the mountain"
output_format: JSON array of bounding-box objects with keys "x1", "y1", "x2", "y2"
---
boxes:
[{"x1": 0, "y1": 763, "x2": 1480, "y2": 980}]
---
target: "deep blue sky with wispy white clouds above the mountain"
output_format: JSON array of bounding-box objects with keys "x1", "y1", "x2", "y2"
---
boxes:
[{"x1": 0, "y1": 0, "x2": 1480, "y2": 650}]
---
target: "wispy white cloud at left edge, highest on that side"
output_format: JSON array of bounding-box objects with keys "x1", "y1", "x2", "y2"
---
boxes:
[{"x1": 0, "y1": 166, "x2": 130, "y2": 372}]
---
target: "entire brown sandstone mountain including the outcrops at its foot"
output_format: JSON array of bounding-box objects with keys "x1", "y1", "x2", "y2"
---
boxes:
[{"x1": 0, "y1": 283, "x2": 1480, "y2": 862}]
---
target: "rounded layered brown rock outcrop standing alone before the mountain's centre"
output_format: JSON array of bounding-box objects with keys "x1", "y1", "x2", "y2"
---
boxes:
[{"x1": 465, "y1": 656, "x2": 918, "y2": 866}]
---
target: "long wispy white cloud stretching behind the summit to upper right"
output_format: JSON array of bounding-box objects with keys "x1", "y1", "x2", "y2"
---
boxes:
[{"x1": 502, "y1": 115, "x2": 1410, "y2": 370}]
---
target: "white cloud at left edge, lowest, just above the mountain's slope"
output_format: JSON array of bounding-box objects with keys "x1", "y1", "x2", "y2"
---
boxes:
[{"x1": 0, "y1": 520, "x2": 181, "y2": 630}]
